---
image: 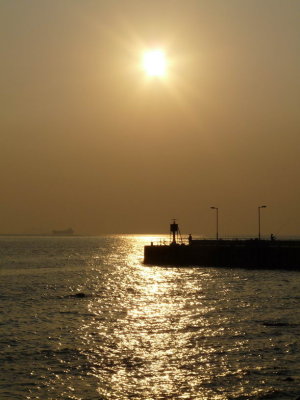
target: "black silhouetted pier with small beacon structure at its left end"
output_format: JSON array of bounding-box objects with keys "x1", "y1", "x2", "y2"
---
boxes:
[{"x1": 144, "y1": 221, "x2": 300, "y2": 271}]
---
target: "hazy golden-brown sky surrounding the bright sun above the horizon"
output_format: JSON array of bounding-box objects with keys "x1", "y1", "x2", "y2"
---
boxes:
[{"x1": 0, "y1": 0, "x2": 300, "y2": 236}]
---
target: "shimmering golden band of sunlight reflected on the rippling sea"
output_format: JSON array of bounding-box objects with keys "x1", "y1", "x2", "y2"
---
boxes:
[{"x1": 75, "y1": 237, "x2": 276, "y2": 400}]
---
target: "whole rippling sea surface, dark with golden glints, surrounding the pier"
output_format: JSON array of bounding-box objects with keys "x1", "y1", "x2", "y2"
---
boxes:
[{"x1": 0, "y1": 236, "x2": 300, "y2": 400}]
